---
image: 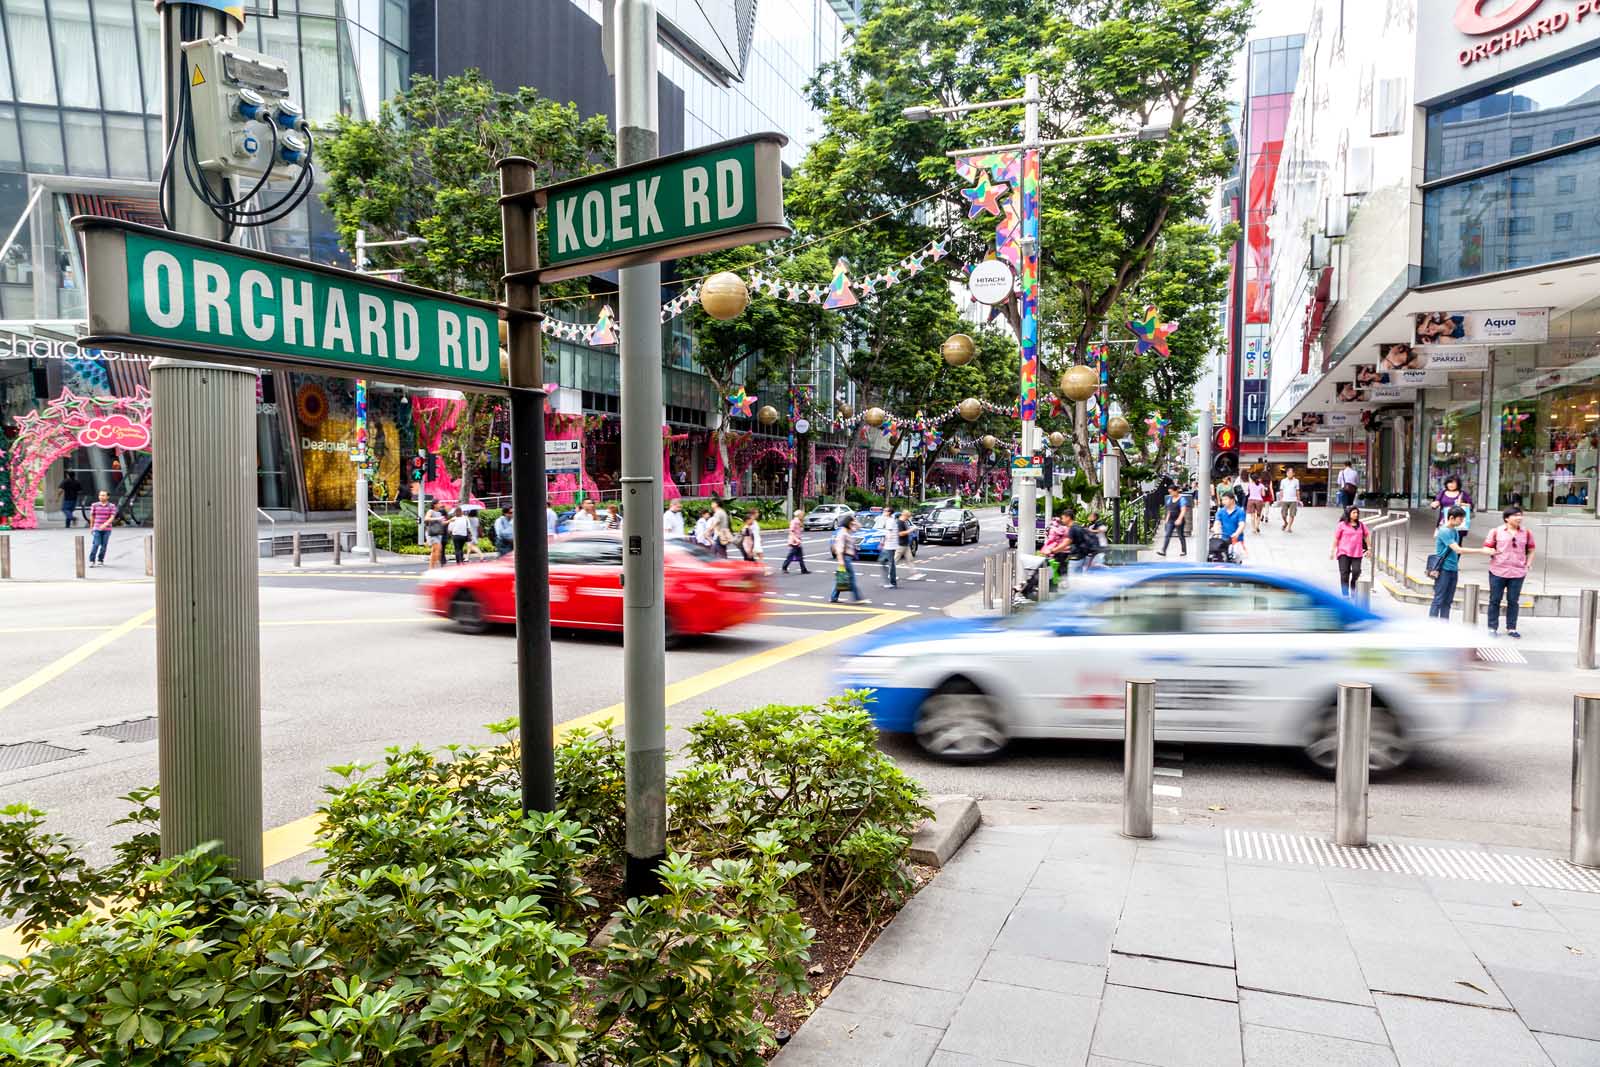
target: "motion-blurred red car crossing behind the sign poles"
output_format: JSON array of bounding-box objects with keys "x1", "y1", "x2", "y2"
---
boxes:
[{"x1": 418, "y1": 531, "x2": 763, "y2": 641}]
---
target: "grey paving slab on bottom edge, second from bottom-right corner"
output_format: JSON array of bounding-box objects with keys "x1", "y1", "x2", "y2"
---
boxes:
[{"x1": 1376, "y1": 995, "x2": 1550, "y2": 1067}]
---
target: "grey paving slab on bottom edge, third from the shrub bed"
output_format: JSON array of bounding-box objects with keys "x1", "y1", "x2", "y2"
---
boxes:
[{"x1": 1091, "y1": 985, "x2": 1242, "y2": 1067}]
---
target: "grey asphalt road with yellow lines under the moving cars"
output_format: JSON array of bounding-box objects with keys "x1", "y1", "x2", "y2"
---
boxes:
[{"x1": 0, "y1": 514, "x2": 1592, "y2": 872}]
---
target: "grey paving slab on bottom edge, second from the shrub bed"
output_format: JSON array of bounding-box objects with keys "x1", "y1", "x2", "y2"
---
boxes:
[{"x1": 939, "y1": 982, "x2": 1099, "y2": 1067}]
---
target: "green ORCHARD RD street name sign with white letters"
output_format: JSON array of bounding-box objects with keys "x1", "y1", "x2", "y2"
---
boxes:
[{"x1": 72, "y1": 216, "x2": 506, "y2": 390}]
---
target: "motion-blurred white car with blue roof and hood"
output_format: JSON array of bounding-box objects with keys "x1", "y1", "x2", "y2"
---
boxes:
[{"x1": 837, "y1": 565, "x2": 1502, "y2": 773}]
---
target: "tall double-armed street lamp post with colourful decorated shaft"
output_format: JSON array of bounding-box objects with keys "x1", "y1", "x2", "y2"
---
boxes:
[{"x1": 901, "y1": 74, "x2": 1171, "y2": 566}]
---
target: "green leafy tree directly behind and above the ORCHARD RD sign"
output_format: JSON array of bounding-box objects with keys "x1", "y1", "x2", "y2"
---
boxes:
[{"x1": 317, "y1": 70, "x2": 613, "y2": 502}]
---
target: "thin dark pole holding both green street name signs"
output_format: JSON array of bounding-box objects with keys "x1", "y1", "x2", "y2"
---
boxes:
[{"x1": 496, "y1": 157, "x2": 555, "y2": 813}]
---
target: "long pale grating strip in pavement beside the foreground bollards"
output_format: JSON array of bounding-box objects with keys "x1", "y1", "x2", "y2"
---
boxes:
[{"x1": 1227, "y1": 830, "x2": 1600, "y2": 893}]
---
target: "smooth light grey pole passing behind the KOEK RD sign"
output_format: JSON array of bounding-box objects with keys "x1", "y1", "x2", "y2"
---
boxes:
[{"x1": 614, "y1": 0, "x2": 667, "y2": 896}]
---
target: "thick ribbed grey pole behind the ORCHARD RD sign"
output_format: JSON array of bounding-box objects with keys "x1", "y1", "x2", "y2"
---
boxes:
[{"x1": 150, "y1": 3, "x2": 262, "y2": 878}]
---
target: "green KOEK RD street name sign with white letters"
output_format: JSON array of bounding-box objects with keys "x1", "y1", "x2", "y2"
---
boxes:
[{"x1": 518, "y1": 133, "x2": 790, "y2": 282}]
